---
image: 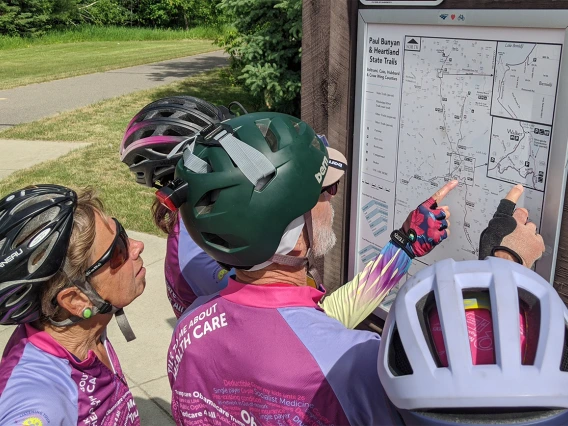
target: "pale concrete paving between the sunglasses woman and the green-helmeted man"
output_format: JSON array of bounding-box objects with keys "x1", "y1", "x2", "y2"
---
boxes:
[{"x1": 0, "y1": 231, "x2": 176, "y2": 426}]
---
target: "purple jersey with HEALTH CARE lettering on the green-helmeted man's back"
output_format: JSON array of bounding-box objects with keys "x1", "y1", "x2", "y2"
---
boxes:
[{"x1": 168, "y1": 279, "x2": 395, "y2": 426}]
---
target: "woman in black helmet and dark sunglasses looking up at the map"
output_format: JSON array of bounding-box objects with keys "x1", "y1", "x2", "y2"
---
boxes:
[{"x1": 0, "y1": 185, "x2": 145, "y2": 426}]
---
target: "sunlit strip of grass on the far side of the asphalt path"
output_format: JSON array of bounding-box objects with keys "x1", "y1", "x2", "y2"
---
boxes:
[{"x1": 0, "y1": 40, "x2": 219, "y2": 90}]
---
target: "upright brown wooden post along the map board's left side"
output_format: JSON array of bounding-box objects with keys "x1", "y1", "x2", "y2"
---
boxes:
[{"x1": 302, "y1": 0, "x2": 358, "y2": 290}]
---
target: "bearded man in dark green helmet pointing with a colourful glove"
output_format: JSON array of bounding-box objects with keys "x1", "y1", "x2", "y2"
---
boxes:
[{"x1": 162, "y1": 113, "x2": 457, "y2": 424}]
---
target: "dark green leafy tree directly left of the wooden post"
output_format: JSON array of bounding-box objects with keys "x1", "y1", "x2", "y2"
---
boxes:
[{"x1": 220, "y1": 0, "x2": 302, "y2": 116}]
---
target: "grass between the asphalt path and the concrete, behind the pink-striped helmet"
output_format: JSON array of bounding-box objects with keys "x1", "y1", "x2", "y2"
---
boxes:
[{"x1": 0, "y1": 70, "x2": 254, "y2": 236}]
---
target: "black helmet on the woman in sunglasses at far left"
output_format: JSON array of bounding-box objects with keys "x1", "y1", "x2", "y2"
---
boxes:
[{"x1": 0, "y1": 185, "x2": 77, "y2": 325}]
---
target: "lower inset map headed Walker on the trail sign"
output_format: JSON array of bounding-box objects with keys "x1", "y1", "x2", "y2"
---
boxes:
[{"x1": 487, "y1": 118, "x2": 551, "y2": 192}]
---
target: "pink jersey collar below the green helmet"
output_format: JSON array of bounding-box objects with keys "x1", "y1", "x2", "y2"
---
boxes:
[{"x1": 220, "y1": 278, "x2": 325, "y2": 309}]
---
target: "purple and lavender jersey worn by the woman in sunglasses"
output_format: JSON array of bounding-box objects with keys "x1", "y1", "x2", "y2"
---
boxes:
[{"x1": 0, "y1": 324, "x2": 140, "y2": 426}]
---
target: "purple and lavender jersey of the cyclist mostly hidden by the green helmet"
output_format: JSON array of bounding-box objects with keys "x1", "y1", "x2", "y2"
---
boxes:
[{"x1": 164, "y1": 218, "x2": 228, "y2": 318}]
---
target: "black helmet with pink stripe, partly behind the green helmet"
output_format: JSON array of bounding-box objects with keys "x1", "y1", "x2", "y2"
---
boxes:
[{"x1": 120, "y1": 96, "x2": 236, "y2": 188}]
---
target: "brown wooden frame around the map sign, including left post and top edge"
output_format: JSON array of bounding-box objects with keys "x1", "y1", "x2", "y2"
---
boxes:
[{"x1": 302, "y1": 0, "x2": 568, "y2": 303}]
